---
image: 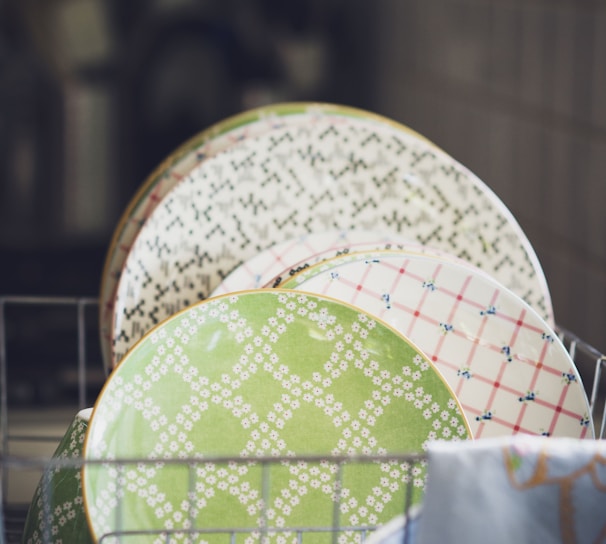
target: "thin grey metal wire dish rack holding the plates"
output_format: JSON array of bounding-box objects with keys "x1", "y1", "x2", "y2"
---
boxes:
[{"x1": 0, "y1": 296, "x2": 606, "y2": 544}]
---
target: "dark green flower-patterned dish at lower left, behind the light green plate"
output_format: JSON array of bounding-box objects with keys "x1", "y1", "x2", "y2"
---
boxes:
[{"x1": 22, "y1": 408, "x2": 93, "y2": 544}]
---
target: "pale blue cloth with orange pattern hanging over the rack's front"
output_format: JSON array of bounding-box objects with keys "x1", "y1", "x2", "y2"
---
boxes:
[{"x1": 418, "y1": 435, "x2": 606, "y2": 544}]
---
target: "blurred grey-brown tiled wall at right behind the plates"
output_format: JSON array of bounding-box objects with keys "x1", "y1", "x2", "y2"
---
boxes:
[{"x1": 370, "y1": 0, "x2": 606, "y2": 352}]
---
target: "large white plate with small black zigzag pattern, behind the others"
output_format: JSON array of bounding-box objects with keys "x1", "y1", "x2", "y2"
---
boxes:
[{"x1": 112, "y1": 117, "x2": 550, "y2": 368}]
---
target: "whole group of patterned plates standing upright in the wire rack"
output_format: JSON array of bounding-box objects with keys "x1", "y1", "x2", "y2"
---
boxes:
[{"x1": 23, "y1": 104, "x2": 593, "y2": 542}]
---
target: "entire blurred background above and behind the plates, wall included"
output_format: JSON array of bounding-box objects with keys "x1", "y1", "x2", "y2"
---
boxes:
[{"x1": 0, "y1": 0, "x2": 606, "y2": 401}]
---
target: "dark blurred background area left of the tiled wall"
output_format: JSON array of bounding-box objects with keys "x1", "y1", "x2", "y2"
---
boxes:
[{"x1": 0, "y1": 0, "x2": 372, "y2": 405}]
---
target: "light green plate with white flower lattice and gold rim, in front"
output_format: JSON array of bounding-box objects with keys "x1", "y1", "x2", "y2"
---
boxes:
[{"x1": 83, "y1": 289, "x2": 470, "y2": 542}]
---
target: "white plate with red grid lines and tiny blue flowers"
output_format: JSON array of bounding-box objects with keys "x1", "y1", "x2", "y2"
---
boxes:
[{"x1": 282, "y1": 251, "x2": 593, "y2": 438}]
